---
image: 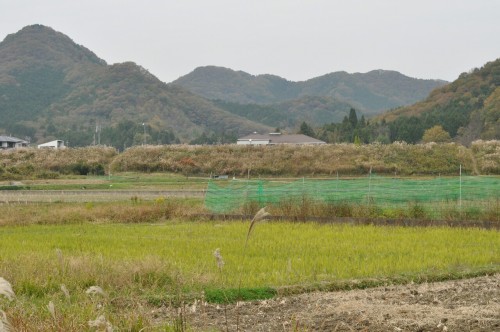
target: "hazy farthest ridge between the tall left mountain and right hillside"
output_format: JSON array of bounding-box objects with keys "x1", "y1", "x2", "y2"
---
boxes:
[{"x1": 172, "y1": 66, "x2": 447, "y2": 114}]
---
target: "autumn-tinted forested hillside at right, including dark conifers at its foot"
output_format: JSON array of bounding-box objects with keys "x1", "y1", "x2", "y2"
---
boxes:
[{"x1": 316, "y1": 59, "x2": 500, "y2": 145}]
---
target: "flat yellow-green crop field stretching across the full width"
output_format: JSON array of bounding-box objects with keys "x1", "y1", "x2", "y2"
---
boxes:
[{"x1": 0, "y1": 221, "x2": 500, "y2": 290}]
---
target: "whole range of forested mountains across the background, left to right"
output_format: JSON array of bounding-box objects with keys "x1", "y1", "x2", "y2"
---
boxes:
[{"x1": 5, "y1": 25, "x2": 492, "y2": 149}]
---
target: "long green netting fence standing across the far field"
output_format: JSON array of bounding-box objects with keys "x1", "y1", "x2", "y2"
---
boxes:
[{"x1": 205, "y1": 175, "x2": 500, "y2": 213}]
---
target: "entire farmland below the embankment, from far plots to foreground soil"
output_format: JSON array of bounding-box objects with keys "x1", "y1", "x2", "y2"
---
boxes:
[{"x1": 0, "y1": 173, "x2": 500, "y2": 331}]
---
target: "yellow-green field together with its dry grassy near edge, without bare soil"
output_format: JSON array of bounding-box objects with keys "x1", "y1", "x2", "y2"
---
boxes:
[{"x1": 0, "y1": 215, "x2": 500, "y2": 331}]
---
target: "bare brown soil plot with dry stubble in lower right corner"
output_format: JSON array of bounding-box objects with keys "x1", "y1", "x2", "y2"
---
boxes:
[{"x1": 157, "y1": 274, "x2": 500, "y2": 331}]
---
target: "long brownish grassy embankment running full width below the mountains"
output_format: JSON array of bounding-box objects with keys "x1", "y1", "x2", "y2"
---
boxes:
[{"x1": 0, "y1": 141, "x2": 500, "y2": 181}]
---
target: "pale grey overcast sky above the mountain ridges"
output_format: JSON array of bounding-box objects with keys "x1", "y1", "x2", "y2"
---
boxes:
[{"x1": 0, "y1": 0, "x2": 500, "y2": 82}]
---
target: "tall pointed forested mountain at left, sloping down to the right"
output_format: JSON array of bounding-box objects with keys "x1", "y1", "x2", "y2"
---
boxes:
[{"x1": 0, "y1": 25, "x2": 270, "y2": 148}]
